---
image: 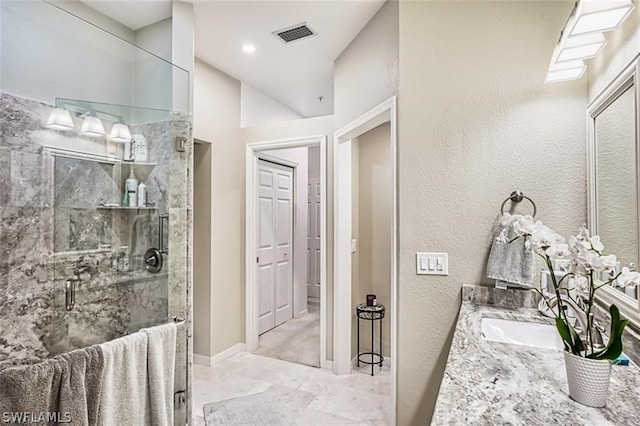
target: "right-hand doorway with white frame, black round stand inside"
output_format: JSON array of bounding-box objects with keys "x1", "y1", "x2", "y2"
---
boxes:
[{"x1": 333, "y1": 97, "x2": 398, "y2": 411}]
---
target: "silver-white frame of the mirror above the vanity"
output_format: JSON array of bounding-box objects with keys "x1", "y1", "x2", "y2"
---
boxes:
[{"x1": 587, "y1": 55, "x2": 640, "y2": 329}]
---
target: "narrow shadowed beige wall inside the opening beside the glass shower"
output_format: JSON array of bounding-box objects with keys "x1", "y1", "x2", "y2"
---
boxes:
[{"x1": 193, "y1": 143, "x2": 212, "y2": 356}]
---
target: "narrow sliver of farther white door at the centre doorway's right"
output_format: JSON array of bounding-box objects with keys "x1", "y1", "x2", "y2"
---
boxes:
[{"x1": 307, "y1": 176, "x2": 321, "y2": 297}]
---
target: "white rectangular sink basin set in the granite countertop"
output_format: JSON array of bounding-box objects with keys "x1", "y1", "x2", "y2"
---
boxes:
[{"x1": 482, "y1": 318, "x2": 564, "y2": 350}]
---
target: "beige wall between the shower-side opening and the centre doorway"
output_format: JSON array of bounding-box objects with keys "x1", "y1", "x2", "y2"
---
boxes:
[{"x1": 193, "y1": 60, "x2": 245, "y2": 356}]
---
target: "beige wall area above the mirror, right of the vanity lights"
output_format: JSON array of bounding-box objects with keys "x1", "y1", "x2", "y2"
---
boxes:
[{"x1": 587, "y1": 3, "x2": 640, "y2": 101}]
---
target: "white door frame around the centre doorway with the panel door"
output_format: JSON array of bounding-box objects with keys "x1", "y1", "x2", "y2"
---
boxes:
[{"x1": 245, "y1": 135, "x2": 327, "y2": 368}]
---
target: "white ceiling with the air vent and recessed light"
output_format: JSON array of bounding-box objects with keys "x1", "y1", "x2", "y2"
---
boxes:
[{"x1": 84, "y1": 0, "x2": 385, "y2": 117}]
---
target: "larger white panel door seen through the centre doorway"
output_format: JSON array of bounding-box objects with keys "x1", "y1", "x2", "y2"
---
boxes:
[{"x1": 257, "y1": 160, "x2": 293, "y2": 334}]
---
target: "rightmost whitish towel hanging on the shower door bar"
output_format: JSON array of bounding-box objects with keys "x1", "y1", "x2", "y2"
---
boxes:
[{"x1": 140, "y1": 323, "x2": 176, "y2": 426}]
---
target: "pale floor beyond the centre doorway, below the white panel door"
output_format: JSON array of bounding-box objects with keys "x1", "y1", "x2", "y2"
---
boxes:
[{"x1": 255, "y1": 297, "x2": 320, "y2": 367}]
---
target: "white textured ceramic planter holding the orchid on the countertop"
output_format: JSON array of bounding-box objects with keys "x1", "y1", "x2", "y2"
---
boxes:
[{"x1": 564, "y1": 352, "x2": 611, "y2": 407}]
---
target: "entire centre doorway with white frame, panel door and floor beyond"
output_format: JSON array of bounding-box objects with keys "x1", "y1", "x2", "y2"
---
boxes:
[{"x1": 245, "y1": 135, "x2": 326, "y2": 368}]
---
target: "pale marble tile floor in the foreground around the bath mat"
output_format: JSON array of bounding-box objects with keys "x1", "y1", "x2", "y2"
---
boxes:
[{"x1": 193, "y1": 352, "x2": 391, "y2": 426}]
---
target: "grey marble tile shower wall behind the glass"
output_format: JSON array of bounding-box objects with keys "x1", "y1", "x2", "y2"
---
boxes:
[{"x1": 0, "y1": 93, "x2": 190, "y2": 368}]
